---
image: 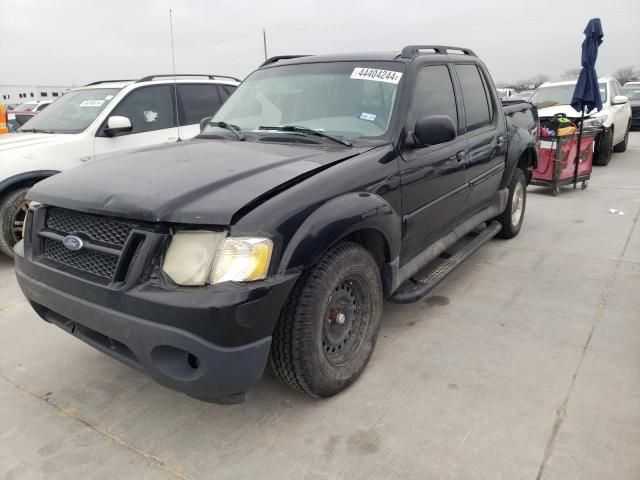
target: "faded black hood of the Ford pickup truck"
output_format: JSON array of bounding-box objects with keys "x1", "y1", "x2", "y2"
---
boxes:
[{"x1": 28, "y1": 139, "x2": 371, "y2": 225}]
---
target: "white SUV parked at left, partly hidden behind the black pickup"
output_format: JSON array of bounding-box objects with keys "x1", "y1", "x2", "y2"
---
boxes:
[{"x1": 0, "y1": 75, "x2": 240, "y2": 256}]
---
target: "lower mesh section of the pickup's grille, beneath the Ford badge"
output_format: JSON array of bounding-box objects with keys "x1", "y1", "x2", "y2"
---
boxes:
[{"x1": 44, "y1": 238, "x2": 118, "y2": 280}]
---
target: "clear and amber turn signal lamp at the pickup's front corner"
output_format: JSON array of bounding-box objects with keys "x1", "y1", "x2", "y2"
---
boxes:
[{"x1": 210, "y1": 237, "x2": 273, "y2": 283}]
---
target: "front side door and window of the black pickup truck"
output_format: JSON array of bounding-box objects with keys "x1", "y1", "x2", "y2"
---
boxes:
[{"x1": 400, "y1": 64, "x2": 468, "y2": 260}]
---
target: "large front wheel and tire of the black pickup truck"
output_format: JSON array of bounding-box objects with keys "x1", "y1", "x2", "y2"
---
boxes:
[{"x1": 271, "y1": 243, "x2": 383, "y2": 397}]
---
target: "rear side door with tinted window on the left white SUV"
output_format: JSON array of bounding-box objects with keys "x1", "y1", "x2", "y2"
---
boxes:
[{"x1": 177, "y1": 83, "x2": 228, "y2": 138}]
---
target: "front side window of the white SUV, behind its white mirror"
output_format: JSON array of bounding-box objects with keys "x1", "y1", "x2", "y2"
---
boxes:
[{"x1": 111, "y1": 85, "x2": 175, "y2": 133}]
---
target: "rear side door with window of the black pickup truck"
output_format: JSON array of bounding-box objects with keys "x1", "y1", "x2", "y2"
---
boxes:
[{"x1": 455, "y1": 63, "x2": 507, "y2": 213}]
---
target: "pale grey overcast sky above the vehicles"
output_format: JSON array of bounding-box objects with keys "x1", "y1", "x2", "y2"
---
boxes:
[{"x1": 0, "y1": 0, "x2": 640, "y2": 85}]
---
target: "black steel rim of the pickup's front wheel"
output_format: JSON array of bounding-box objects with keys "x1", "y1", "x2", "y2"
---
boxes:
[{"x1": 322, "y1": 276, "x2": 372, "y2": 366}]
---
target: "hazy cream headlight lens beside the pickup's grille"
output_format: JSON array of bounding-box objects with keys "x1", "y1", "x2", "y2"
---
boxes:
[{"x1": 162, "y1": 230, "x2": 226, "y2": 286}]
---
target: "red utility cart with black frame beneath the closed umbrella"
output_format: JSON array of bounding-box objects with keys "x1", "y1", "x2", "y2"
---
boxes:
[{"x1": 530, "y1": 118, "x2": 599, "y2": 197}]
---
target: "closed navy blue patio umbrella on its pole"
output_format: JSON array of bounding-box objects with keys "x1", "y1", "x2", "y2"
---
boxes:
[{"x1": 571, "y1": 18, "x2": 604, "y2": 188}]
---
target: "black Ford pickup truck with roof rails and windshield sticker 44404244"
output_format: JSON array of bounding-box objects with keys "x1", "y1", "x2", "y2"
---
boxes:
[{"x1": 15, "y1": 45, "x2": 538, "y2": 403}]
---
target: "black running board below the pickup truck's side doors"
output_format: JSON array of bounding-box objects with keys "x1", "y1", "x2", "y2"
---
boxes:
[{"x1": 390, "y1": 220, "x2": 502, "y2": 303}]
